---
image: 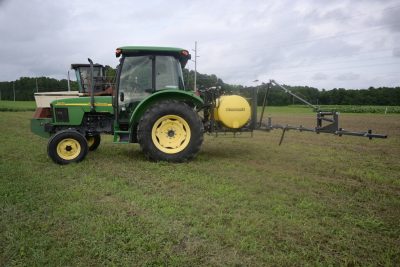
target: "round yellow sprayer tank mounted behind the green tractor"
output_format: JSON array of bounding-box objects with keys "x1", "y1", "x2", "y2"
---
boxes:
[{"x1": 214, "y1": 95, "x2": 251, "y2": 129}]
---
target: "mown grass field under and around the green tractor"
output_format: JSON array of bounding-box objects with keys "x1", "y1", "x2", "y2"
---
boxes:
[{"x1": 0, "y1": 109, "x2": 400, "y2": 266}]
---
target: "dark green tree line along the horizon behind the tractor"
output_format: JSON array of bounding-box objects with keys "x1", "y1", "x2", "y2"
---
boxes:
[{"x1": 0, "y1": 69, "x2": 400, "y2": 106}]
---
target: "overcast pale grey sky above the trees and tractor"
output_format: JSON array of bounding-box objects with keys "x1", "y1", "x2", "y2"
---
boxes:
[{"x1": 0, "y1": 0, "x2": 400, "y2": 90}]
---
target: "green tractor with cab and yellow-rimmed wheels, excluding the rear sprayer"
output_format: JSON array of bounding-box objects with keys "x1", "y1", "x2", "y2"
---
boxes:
[{"x1": 31, "y1": 46, "x2": 203, "y2": 164}]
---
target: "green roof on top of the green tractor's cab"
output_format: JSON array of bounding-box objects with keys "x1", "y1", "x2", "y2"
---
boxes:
[{"x1": 115, "y1": 46, "x2": 191, "y2": 67}]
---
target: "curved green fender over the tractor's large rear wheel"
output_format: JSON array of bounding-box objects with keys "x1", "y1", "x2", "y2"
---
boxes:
[{"x1": 129, "y1": 90, "x2": 204, "y2": 125}]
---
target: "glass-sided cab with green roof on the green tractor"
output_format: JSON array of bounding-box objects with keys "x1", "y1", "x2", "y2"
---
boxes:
[{"x1": 115, "y1": 46, "x2": 190, "y2": 122}]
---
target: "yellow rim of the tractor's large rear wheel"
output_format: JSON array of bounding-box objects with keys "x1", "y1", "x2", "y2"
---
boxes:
[{"x1": 151, "y1": 115, "x2": 191, "y2": 154}]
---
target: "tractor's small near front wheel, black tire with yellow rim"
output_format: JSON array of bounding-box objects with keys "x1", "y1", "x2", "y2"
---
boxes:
[{"x1": 47, "y1": 130, "x2": 88, "y2": 165}]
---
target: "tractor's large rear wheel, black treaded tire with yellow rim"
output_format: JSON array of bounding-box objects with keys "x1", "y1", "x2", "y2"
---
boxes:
[{"x1": 137, "y1": 100, "x2": 204, "y2": 162}]
